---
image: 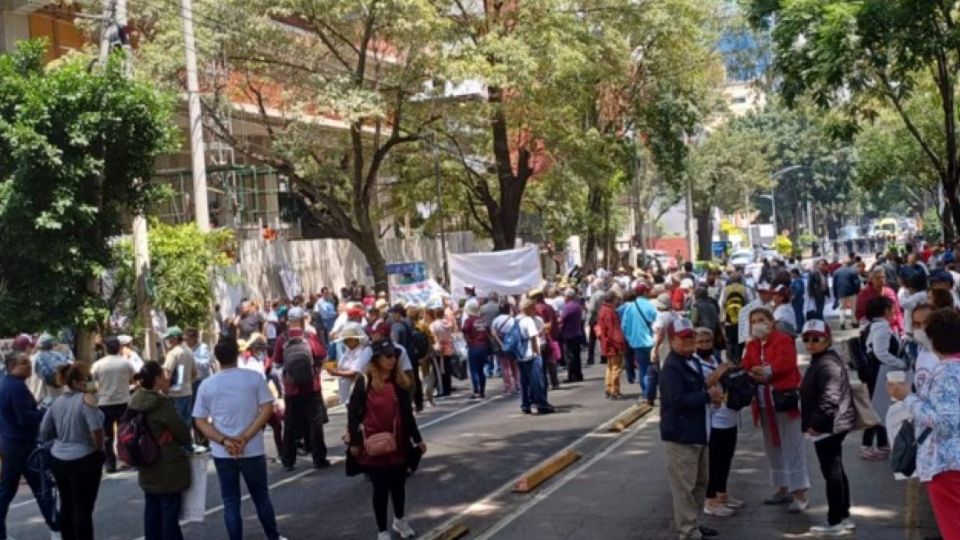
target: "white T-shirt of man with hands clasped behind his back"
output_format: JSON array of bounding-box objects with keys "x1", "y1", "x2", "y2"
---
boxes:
[{"x1": 193, "y1": 368, "x2": 273, "y2": 458}]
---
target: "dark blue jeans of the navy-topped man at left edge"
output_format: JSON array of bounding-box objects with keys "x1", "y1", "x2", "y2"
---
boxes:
[{"x1": 0, "y1": 441, "x2": 60, "y2": 538}]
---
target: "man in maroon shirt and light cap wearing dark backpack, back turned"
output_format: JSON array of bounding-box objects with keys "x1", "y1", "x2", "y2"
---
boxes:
[{"x1": 269, "y1": 307, "x2": 330, "y2": 471}]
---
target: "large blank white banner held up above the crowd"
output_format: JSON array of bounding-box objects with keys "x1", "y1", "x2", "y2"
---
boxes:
[{"x1": 450, "y1": 246, "x2": 543, "y2": 299}]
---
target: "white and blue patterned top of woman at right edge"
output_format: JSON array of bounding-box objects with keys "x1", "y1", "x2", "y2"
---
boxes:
[{"x1": 905, "y1": 358, "x2": 960, "y2": 482}]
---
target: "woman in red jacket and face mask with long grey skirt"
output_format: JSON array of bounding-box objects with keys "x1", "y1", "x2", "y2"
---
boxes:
[{"x1": 742, "y1": 308, "x2": 810, "y2": 512}]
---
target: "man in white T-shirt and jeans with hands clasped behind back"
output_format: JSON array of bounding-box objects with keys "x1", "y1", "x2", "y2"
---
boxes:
[{"x1": 193, "y1": 338, "x2": 286, "y2": 540}]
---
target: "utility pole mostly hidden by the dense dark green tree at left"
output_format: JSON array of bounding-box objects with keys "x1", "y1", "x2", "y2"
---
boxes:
[{"x1": 100, "y1": 0, "x2": 156, "y2": 360}]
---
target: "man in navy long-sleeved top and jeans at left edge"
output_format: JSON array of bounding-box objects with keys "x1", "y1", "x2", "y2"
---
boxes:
[{"x1": 0, "y1": 351, "x2": 60, "y2": 540}]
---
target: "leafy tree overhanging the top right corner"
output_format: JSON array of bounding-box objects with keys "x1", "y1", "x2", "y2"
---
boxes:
[{"x1": 749, "y1": 0, "x2": 960, "y2": 237}]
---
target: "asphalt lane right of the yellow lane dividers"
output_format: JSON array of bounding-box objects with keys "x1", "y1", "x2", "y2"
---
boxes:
[{"x1": 494, "y1": 411, "x2": 937, "y2": 540}]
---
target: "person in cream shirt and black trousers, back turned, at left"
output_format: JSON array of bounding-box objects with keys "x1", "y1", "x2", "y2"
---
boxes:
[{"x1": 90, "y1": 336, "x2": 137, "y2": 474}]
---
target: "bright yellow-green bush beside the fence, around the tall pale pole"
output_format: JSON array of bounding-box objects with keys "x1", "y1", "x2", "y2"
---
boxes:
[{"x1": 109, "y1": 221, "x2": 234, "y2": 328}]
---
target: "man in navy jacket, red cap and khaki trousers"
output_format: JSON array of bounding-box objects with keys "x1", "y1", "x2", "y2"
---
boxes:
[{"x1": 660, "y1": 319, "x2": 723, "y2": 540}]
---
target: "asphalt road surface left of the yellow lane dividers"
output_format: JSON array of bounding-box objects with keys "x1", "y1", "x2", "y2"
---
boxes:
[{"x1": 7, "y1": 367, "x2": 637, "y2": 540}]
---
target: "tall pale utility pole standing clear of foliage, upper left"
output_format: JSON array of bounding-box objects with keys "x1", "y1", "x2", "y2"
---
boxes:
[{"x1": 180, "y1": 0, "x2": 210, "y2": 232}]
